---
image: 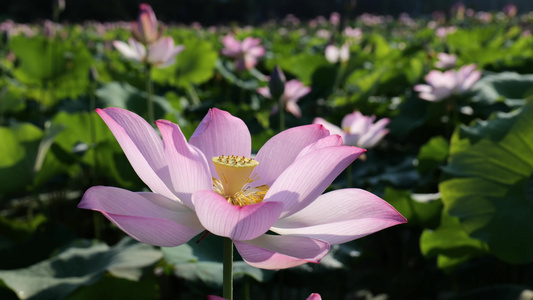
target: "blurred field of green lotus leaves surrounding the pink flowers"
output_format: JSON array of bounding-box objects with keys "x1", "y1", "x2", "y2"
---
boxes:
[{"x1": 0, "y1": 0, "x2": 533, "y2": 300}]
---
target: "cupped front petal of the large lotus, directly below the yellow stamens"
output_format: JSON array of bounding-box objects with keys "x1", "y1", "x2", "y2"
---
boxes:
[{"x1": 192, "y1": 191, "x2": 283, "y2": 240}]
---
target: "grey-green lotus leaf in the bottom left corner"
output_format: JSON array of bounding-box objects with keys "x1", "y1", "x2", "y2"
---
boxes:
[{"x1": 0, "y1": 238, "x2": 161, "y2": 299}]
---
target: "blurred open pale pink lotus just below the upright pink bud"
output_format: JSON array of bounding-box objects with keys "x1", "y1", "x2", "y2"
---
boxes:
[{"x1": 113, "y1": 36, "x2": 185, "y2": 68}]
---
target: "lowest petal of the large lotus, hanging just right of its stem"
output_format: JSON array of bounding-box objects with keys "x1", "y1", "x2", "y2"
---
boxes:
[{"x1": 234, "y1": 234, "x2": 330, "y2": 269}]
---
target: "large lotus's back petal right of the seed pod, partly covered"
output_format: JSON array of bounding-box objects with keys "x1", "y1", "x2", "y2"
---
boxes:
[{"x1": 254, "y1": 124, "x2": 329, "y2": 186}]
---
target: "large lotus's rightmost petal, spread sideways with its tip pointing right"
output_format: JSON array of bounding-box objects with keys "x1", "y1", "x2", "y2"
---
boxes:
[{"x1": 271, "y1": 189, "x2": 407, "y2": 245}]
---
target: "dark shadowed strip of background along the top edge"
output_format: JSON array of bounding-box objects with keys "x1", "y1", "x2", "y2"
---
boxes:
[{"x1": 0, "y1": 0, "x2": 533, "y2": 25}]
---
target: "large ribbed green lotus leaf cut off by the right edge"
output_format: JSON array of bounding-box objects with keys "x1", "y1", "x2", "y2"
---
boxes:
[{"x1": 439, "y1": 103, "x2": 533, "y2": 263}]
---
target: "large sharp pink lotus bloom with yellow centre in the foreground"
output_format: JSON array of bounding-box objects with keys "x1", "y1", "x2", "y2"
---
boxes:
[{"x1": 78, "y1": 108, "x2": 406, "y2": 269}]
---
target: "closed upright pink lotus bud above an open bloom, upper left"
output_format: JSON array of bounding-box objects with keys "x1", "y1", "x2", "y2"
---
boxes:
[{"x1": 131, "y1": 3, "x2": 161, "y2": 45}]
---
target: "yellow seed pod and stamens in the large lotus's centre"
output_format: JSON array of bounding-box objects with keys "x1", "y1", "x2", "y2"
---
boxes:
[{"x1": 211, "y1": 155, "x2": 269, "y2": 206}]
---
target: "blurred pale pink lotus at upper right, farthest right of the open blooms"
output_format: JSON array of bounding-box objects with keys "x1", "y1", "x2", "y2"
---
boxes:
[{"x1": 413, "y1": 64, "x2": 481, "y2": 102}]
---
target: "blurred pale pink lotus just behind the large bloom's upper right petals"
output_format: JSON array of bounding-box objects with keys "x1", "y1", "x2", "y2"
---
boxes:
[{"x1": 313, "y1": 111, "x2": 390, "y2": 149}]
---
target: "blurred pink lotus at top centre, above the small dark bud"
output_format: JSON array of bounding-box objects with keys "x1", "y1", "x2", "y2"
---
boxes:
[{"x1": 222, "y1": 35, "x2": 265, "y2": 71}]
